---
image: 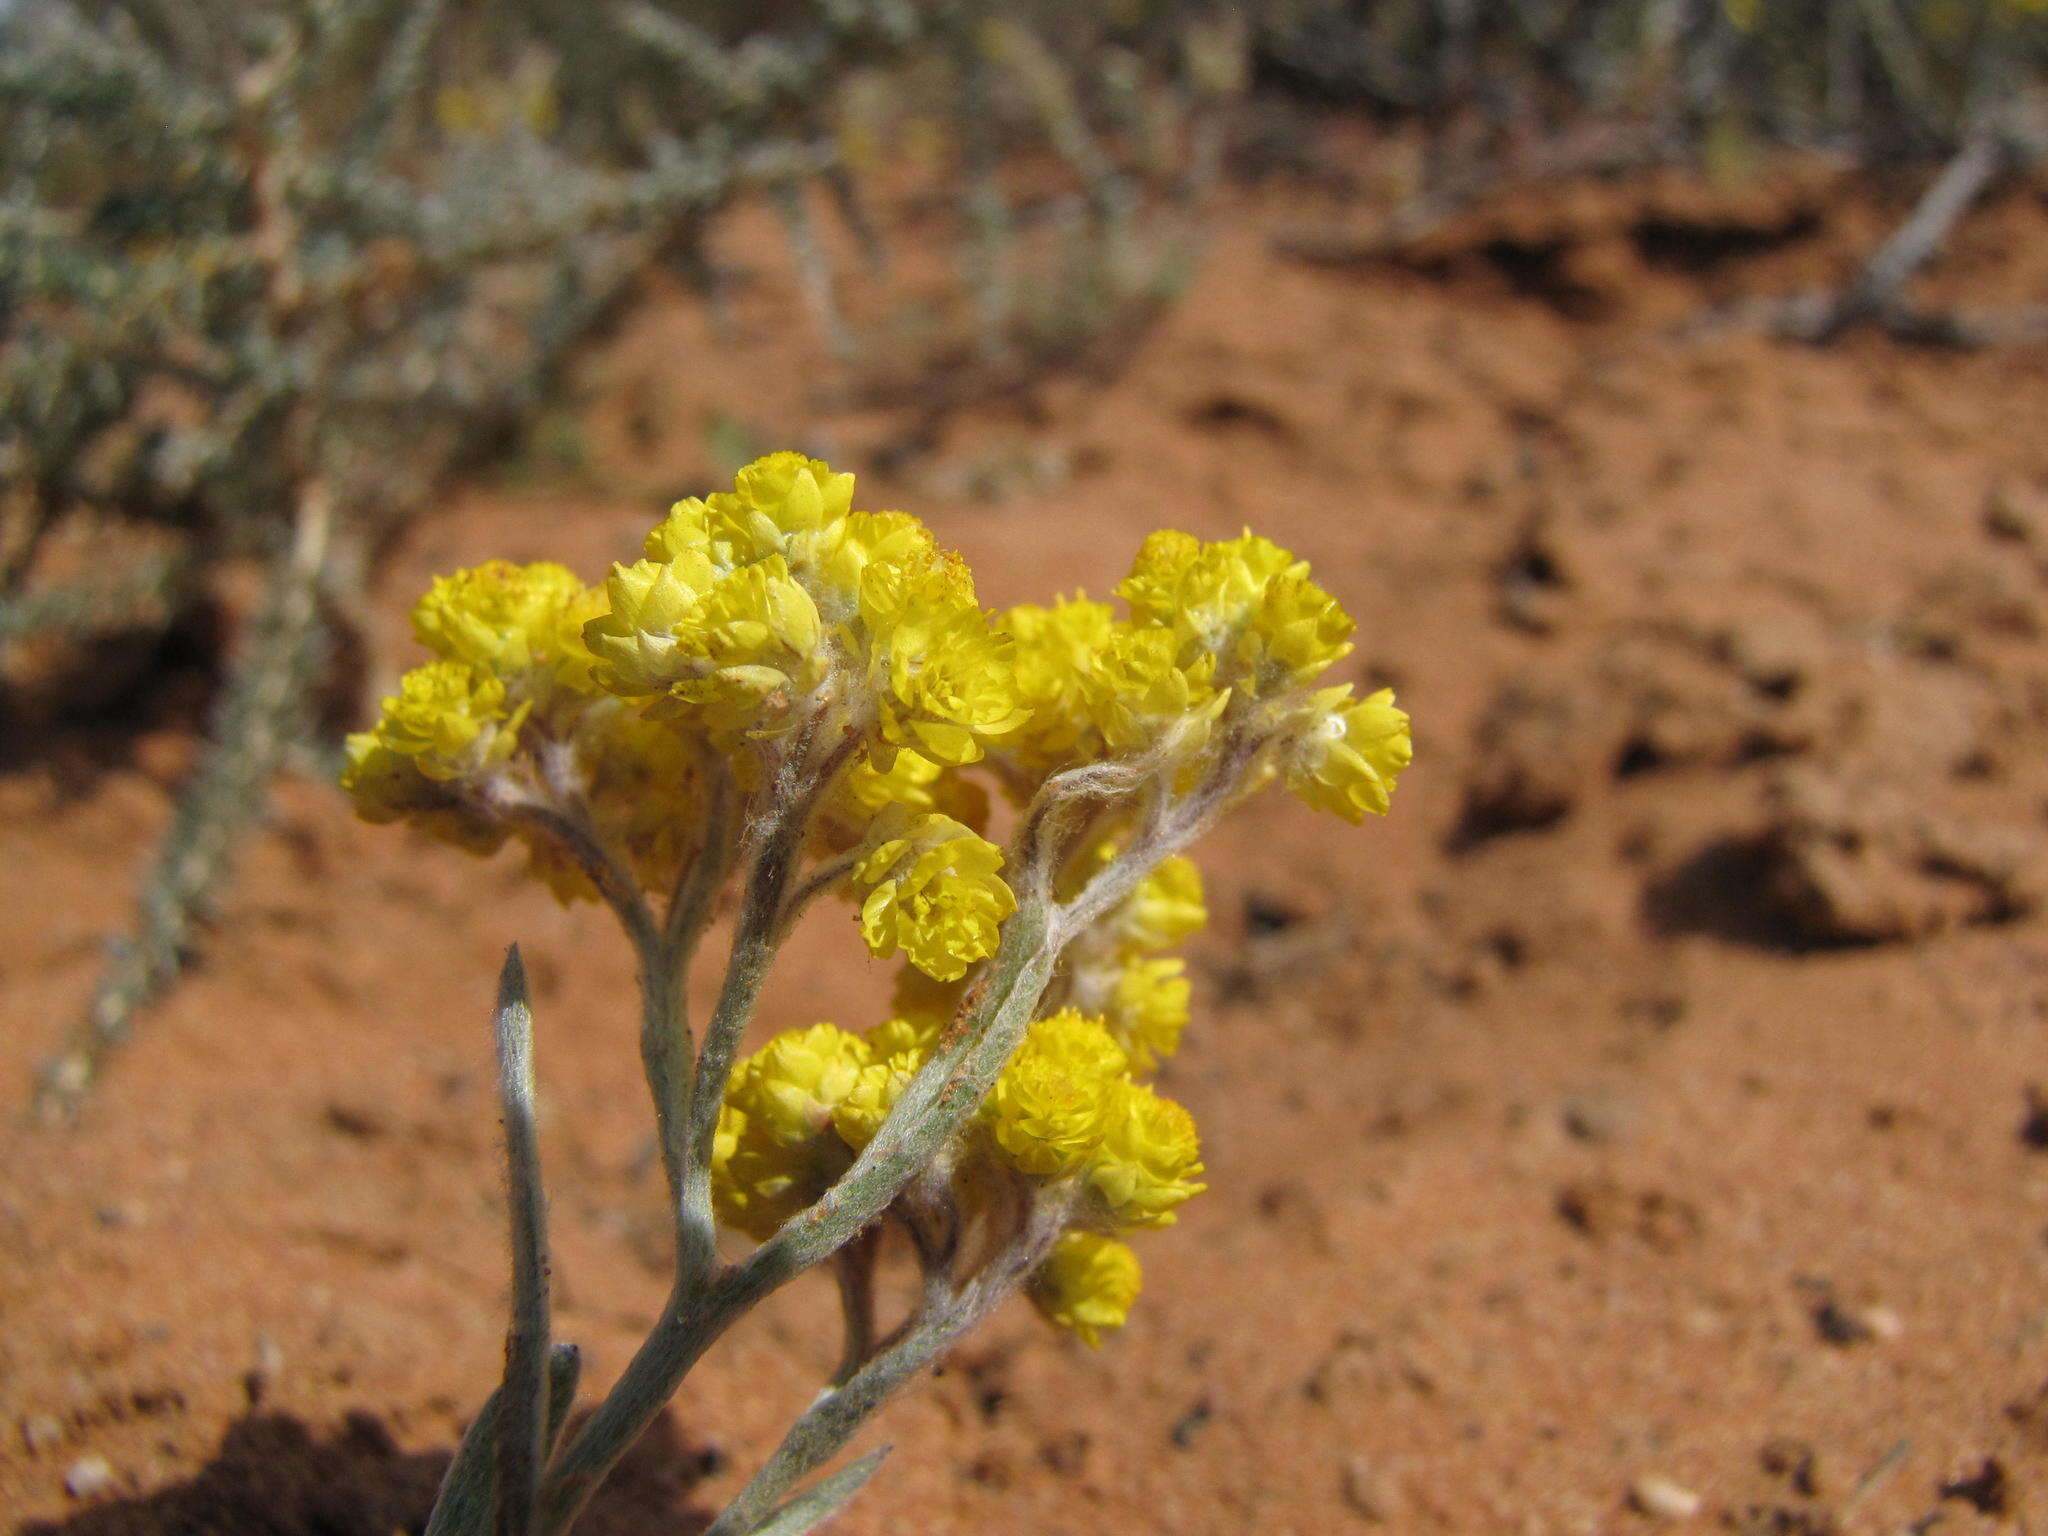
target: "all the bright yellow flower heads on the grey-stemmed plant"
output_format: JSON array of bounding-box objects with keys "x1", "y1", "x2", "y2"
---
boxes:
[{"x1": 344, "y1": 453, "x2": 1409, "y2": 1339}]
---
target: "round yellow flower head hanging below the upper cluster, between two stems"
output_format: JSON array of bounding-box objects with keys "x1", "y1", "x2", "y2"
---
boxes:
[{"x1": 852, "y1": 813, "x2": 1016, "y2": 981}]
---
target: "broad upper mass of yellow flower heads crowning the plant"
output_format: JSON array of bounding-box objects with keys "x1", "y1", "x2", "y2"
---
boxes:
[{"x1": 344, "y1": 453, "x2": 1409, "y2": 987}]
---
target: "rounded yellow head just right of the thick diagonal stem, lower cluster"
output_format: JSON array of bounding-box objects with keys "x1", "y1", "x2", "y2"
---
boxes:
[{"x1": 983, "y1": 1008, "x2": 1128, "y2": 1178}]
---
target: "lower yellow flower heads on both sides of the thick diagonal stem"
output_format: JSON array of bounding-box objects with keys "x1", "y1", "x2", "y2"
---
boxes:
[{"x1": 713, "y1": 1008, "x2": 1204, "y2": 1343}]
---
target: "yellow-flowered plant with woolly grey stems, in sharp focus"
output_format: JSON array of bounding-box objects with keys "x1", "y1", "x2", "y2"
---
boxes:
[{"x1": 344, "y1": 453, "x2": 1409, "y2": 1536}]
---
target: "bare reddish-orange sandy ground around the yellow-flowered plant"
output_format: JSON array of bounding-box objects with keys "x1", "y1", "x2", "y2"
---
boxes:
[{"x1": 12, "y1": 162, "x2": 2048, "y2": 1536}]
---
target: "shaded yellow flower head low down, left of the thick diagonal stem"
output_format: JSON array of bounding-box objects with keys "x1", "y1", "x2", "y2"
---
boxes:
[{"x1": 711, "y1": 1024, "x2": 872, "y2": 1239}]
